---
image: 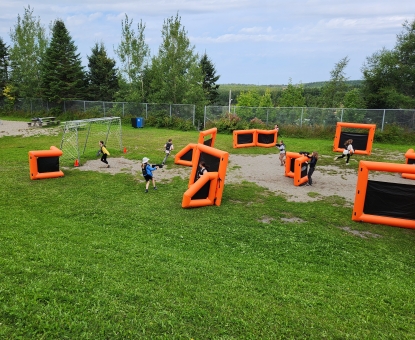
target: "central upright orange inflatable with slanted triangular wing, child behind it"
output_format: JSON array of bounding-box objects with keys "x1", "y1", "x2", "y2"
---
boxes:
[{"x1": 182, "y1": 144, "x2": 229, "y2": 208}]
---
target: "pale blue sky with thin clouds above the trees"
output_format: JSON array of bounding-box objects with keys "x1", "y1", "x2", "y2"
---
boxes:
[{"x1": 0, "y1": 0, "x2": 415, "y2": 85}]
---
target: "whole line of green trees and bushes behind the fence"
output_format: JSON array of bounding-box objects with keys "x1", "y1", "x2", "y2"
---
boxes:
[{"x1": 0, "y1": 6, "x2": 415, "y2": 113}]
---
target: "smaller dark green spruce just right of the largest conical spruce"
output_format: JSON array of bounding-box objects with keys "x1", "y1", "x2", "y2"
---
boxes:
[{"x1": 87, "y1": 42, "x2": 119, "y2": 101}]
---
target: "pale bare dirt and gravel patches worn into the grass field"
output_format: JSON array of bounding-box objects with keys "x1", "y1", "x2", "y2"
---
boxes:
[{"x1": 0, "y1": 121, "x2": 414, "y2": 205}]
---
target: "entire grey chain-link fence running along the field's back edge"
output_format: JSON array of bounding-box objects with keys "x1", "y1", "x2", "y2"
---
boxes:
[{"x1": 0, "y1": 98, "x2": 415, "y2": 131}]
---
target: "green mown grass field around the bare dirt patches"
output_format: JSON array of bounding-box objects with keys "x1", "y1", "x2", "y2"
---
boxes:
[{"x1": 0, "y1": 121, "x2": 415, "y2": 339}]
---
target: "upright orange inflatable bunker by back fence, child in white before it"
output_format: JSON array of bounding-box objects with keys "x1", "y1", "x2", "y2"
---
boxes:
[{"x1": 333, "y1": 122, "x2": 376, "y2": 155}]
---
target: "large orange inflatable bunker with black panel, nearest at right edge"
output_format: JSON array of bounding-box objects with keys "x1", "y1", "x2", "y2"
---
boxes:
[{"x1": 352, "y1": 161, "x2": 415, "y2": 229}]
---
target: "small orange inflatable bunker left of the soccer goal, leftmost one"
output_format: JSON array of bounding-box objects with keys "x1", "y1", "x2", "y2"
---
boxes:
[{"x1": 29, "y1": 146, "x2": 64, "y2": 179}]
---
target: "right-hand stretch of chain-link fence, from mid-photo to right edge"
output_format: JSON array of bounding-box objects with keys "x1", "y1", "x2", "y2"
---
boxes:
[{"x1": 204, "y1": 106, "x2": 415, "y2": 131}]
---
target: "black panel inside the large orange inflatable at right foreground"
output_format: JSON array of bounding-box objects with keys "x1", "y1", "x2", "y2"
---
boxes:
[{"x1": 363, "y1": 180, "x2": 415, "y2": 221}]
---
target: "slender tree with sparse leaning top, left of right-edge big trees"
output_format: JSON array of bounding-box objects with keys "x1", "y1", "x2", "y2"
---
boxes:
[{"x1": 321, "y1": 56, "x2": 349, "y2": 108}]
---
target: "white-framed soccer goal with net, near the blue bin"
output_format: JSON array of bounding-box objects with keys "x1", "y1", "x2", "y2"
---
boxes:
[{"x1": 60, "y1": 117, "x2": 122, "y2": 160}]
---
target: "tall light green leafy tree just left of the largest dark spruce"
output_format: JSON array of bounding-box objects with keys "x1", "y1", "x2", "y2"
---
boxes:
[{"x1": 9, "y1": 6, "x2": 48, "y2": 98}]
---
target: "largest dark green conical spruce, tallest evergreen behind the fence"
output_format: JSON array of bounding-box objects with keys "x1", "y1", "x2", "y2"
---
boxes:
[{"x1": 42, "y1": 20, "x2": 87, "y2": 103}]
